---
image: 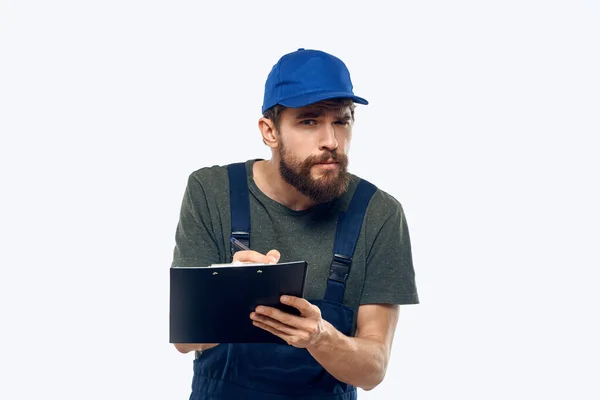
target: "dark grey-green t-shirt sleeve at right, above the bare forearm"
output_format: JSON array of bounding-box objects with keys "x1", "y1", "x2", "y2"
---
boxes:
[{"x1": 360, "y1": 201, "x2": 419, "y2": 304}]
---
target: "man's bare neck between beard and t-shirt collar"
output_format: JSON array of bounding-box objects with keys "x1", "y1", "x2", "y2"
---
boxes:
[{"x1": 252, "y1": 158, "x2": 315, "y2": 211}]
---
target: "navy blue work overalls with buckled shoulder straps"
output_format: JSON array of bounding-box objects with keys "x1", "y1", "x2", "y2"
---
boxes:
[{"x1": 190, "y1": 163, "x2": 376, "y2": 400}]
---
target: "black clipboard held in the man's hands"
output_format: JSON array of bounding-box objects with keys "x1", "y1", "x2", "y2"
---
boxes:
[{"x1": 169, "y1": 261, "x2": 307, "y2": 343}]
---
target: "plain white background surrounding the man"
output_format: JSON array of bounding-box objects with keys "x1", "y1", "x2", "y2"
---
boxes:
[{"x1": 0, "y1": 0, "x2": 600, "y2": 400}]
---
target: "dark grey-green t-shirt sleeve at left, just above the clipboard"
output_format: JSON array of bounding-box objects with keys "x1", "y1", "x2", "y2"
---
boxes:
[{"x1": 171, "y1": 174, "x2": 219, "y2": 267}]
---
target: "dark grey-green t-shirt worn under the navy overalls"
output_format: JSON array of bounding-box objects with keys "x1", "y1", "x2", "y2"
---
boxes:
[{"x1": 172, "y1": 160, "x2": 419, "y2": 332}]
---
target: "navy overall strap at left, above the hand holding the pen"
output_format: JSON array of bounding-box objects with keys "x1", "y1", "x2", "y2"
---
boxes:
[{"x1": 227, "y1": 162, "x2": 250, "y2": 257}]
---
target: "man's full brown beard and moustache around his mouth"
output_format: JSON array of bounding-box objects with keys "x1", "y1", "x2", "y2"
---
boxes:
[{"x1": 279, "y1": 142, "x2": 350, "y2": 204}]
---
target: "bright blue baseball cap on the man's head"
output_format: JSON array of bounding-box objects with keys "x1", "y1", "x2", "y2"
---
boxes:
[{"x1": 262, "y1": 49, "x2": 369, "y2": 113}]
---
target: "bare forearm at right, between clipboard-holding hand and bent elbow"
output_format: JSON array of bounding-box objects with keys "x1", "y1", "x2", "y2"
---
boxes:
[{"x1": 307, "y1": 323, "x2": 389, "y2": 390}]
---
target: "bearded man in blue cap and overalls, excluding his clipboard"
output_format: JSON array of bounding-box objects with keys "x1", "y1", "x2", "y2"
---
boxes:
[{"x1": 173, "y1": 49, "x2": 419, "y2": 400}]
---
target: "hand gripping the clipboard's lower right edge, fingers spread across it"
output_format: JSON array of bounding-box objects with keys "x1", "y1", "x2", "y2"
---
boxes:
[{"x1": 250, "y1": 296, "x2": 332, "y2": 348}]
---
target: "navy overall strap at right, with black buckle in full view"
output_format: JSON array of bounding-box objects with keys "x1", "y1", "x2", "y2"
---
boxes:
[{"x1": 325, "y1": 179, "x2": 377, "y2": 303}]
